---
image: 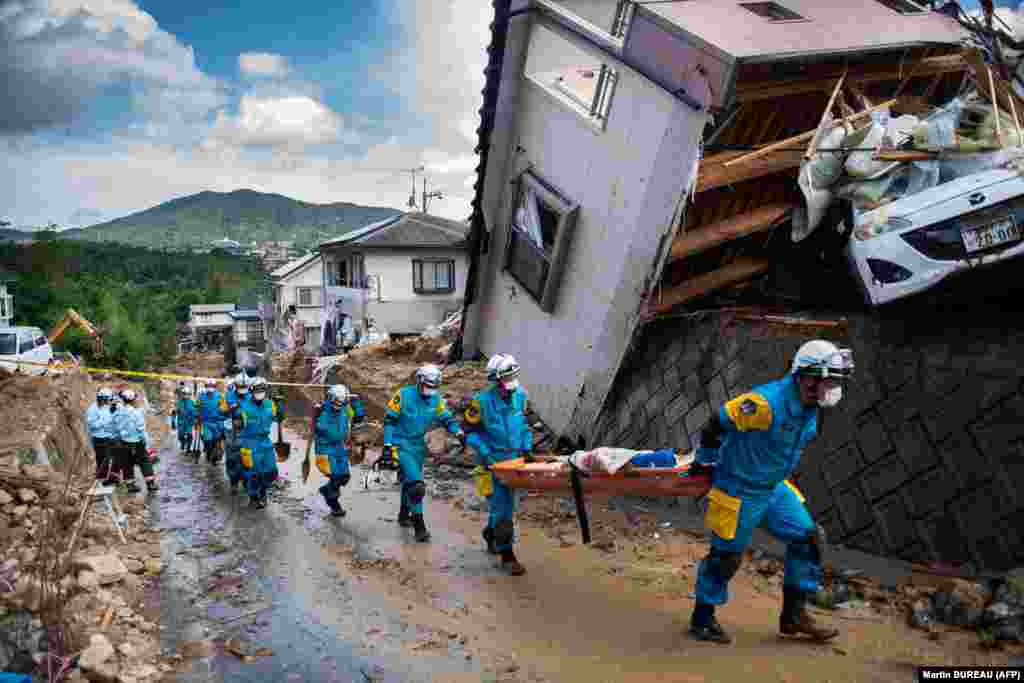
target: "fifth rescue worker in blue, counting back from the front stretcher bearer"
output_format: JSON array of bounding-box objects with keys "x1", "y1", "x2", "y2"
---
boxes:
[{"x1": 239, "y1": 377, "x2": 285, "y2": 510}]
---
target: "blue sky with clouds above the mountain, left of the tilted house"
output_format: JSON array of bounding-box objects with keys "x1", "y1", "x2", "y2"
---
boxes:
[{"x1": 0, "y1": 0, "x2": 492, "y2": 226}]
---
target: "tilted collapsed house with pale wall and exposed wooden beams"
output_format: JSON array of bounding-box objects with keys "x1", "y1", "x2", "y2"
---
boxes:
[{"x1": 463, "y1": 0, "x2": 966, "y2": 438}]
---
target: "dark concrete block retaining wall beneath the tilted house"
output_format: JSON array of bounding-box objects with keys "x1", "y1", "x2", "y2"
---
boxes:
[{"x1": 588, "y1": 312, "x2": 1024, "y2": 570}]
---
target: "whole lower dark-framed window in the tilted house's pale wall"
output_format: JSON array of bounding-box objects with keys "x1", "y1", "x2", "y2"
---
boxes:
[{"x1": 505, "y1": 171, "x2": 579, "y2": 313}]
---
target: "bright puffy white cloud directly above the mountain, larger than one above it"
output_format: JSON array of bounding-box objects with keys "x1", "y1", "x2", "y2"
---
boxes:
[{"x1": 204, "y1": 95, "x2": 355, "y2": 146}]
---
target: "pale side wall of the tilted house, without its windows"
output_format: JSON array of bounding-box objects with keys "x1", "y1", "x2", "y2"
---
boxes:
[{"x1": 466, "y1": 12, "x2": 705, "y2": 432}]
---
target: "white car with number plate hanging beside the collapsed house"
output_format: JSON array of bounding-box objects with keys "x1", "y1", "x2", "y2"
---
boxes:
[{"x1": 847, "y1": 169, "x2": 1024, "y2": 306}]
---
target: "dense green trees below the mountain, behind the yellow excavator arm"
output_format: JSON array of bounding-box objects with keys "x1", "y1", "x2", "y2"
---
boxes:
[{"x1": 0, "y1": 233, "x2": 264, "y2": 370}]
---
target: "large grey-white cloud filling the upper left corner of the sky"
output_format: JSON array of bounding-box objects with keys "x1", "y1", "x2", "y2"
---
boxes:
[{"x1": 0, "y1": 0, "x2": 222, "y2": 134}]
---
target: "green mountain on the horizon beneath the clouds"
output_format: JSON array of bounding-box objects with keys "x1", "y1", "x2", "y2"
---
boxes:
[{"x1": 76, "y1": 189, "x2": 398, "y2": 250}]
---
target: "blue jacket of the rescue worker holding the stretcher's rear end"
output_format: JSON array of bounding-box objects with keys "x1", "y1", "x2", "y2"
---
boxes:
[{"x1": 465, "y1": 387, "x2": 534, "y2": 466}]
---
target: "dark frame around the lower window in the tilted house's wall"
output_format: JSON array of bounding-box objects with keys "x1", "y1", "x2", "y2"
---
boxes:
[{"x1": 502, "y1": 171, "x2": 580, "y2": 313}]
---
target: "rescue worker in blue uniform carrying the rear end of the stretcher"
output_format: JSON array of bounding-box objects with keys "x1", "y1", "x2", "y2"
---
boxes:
[{"x1": 465, "y1": 355, "x2": 534, "y2": 577}]
